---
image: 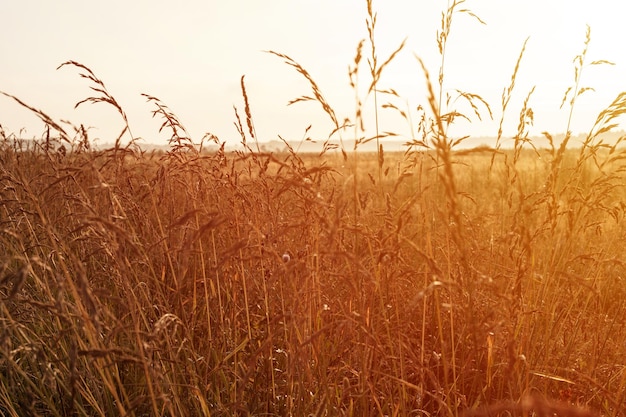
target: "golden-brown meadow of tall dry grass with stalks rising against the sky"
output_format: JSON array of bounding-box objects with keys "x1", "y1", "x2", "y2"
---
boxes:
[{"x1": 0, "y1": 1, "x2": 626, "y2": 416}]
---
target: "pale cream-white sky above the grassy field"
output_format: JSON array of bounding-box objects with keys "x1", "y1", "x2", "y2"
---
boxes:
[{"x1": 0, "y1": 0, "x2": 626, "y2": 144}]
